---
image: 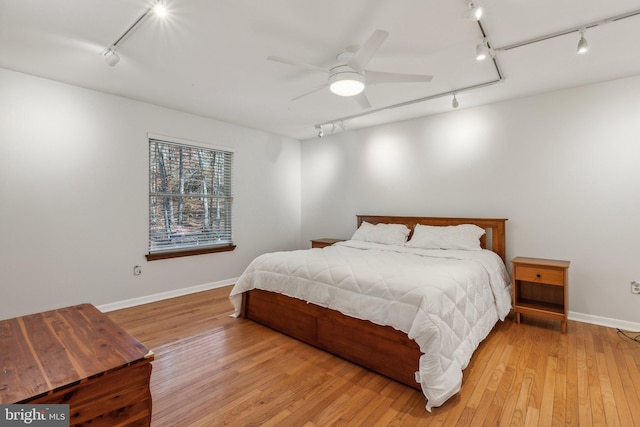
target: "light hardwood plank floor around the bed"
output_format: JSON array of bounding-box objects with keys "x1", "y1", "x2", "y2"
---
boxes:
[{"x1": 108, "y1": 288, "x2": 640, "y2": 427}]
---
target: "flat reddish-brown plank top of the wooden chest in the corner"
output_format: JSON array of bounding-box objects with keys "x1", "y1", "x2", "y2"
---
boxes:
[{"x1": 0, "y1": 304, "x2": 153, "y2": 404}]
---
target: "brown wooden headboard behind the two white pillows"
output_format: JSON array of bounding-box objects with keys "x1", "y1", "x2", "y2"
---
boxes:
[{"x1": 357, "y1": 215, "x2": 507, "y2": 262}]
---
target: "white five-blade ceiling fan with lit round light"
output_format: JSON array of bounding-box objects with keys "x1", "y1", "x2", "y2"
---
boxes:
[{"x1": 267, "y1": 30, "x2": 433, "y2": 108}]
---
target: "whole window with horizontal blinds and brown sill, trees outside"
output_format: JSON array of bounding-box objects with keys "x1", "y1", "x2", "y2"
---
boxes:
[{"x1": 147, "y1": 137, "x2": 235, "y2": 261}]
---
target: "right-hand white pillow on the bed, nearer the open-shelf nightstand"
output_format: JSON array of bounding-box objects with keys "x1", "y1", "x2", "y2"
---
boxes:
[{"x1": 406, "y1": 224, "x2": 485, "y2": 250}]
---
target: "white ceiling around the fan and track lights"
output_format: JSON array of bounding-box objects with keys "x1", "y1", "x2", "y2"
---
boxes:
[{"x1": 0, "y1": 0, "x2": 640, "y2": 139}]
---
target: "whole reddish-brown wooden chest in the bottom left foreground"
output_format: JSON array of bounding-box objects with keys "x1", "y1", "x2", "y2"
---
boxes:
[{"x1": 0, "y1": 304, "x2": 153, "y2": 426}]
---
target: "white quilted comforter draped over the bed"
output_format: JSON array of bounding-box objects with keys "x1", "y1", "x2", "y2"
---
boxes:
[{"x1": 230, "y1": 240, "x2": 511, "y2": 411}]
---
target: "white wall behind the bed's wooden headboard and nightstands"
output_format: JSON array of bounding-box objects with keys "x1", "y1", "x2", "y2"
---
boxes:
[{"x1": 302, "y1": 77, "x2": 640, "y2": 325}]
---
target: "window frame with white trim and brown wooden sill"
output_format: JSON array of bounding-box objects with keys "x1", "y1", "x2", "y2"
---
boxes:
[{"x1": 146, "y1": 133, "x2": 236, "y2": 261}]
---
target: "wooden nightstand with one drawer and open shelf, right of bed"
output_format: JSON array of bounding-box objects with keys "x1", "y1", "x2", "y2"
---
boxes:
[{"x1": 511, "y1": 257, "x2": 570, "y2": 332}]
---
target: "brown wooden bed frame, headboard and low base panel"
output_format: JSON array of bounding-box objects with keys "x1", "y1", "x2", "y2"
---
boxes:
[{"x1": 241, "y1": 215, "x2": 507, "y2": 390}]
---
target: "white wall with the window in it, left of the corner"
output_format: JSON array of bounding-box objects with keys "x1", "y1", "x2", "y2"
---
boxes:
[{"x1": 0, "y1": 69, "x2": 305, "y2": 318}]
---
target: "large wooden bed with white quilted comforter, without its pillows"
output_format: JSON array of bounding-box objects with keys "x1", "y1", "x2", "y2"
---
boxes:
[{"x1": 230, "y1": 215, "x2": 511, "y2": 411}]
